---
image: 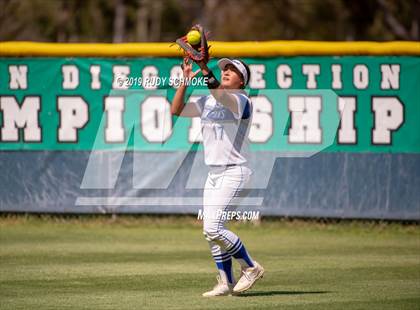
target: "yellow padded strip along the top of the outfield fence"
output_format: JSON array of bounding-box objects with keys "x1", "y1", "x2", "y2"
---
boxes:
[{"x1": 0, "y1": 41, "x2": 420, "y2": 57}]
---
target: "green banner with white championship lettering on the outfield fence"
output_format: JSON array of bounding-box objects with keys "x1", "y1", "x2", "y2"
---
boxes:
[{"x1": 0, "y1": 56, "x2": 420, "y2": 153}]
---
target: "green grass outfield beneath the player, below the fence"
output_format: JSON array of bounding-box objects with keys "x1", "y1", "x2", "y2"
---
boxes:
[{"x1": 0, "y1": 216, "x2": 420, "y2": 309}]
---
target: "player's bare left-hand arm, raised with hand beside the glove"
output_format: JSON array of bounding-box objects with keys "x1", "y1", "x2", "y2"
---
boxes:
[{"x1": 171, "y1": 59, "x2": 201, "y2": 117}]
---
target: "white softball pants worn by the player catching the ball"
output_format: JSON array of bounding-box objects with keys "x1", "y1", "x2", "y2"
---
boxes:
[{"x1": 203, "y1": 165, "x2": 252, "y2": 256}]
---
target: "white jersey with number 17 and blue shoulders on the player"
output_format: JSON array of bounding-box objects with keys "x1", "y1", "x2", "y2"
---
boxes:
[{"x1": 195, "y1": 93, "x2": 252, "y2": 166}]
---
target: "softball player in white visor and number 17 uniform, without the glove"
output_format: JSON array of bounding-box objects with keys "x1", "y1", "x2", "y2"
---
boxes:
[{"x1": 171, "y1": 58, "x2": 264, "y2": 297}]
